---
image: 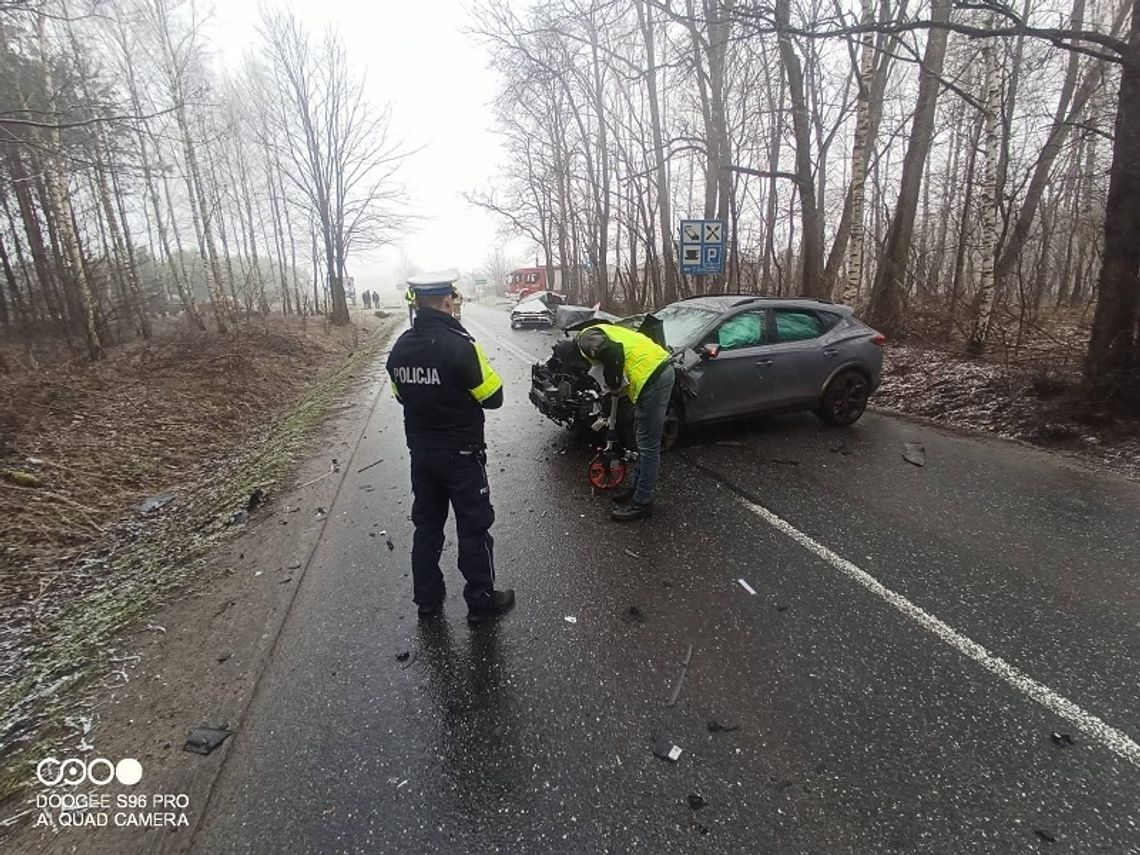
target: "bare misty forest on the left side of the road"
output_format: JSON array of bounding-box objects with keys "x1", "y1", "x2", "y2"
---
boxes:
[{"x1": 0, "y1": 0, "x2": 406, "y2": 369}]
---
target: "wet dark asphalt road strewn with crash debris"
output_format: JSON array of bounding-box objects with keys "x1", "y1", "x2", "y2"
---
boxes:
[{"x1": 195, "y1": 306, "x2": 1140, "y2": 854}]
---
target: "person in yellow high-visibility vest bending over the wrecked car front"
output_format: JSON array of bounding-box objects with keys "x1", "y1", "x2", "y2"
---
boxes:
[{"x1": 577, "y1": 324, "x2": 674, "y2": 522}]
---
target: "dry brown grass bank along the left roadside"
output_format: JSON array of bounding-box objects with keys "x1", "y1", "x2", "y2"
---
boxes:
[{"x1": 0, "y1": 315, "x2": 399, "y2": 798}]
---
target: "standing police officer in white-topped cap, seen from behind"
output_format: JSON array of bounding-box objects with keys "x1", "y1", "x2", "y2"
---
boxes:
[{"x1": 388, "y1": 271, "x2": 514, "y2": 624}]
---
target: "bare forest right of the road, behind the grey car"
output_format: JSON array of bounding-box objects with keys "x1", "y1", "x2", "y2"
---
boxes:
[{"x1": 473, "y1": 0, "x2": 1140, "y2": 394}]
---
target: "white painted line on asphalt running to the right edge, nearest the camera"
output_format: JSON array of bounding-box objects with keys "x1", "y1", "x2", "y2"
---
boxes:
[{"x1": 740, "y1": 499, "x2": 1140, "y2": 767}]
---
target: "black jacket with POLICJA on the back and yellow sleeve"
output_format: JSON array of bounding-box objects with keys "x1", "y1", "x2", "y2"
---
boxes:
[{"x1": 388, "y1": 308, "x2": 503, "y2": 450}]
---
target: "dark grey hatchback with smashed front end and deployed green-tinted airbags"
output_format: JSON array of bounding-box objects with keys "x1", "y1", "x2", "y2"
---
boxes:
[{"x1": 530, "y1": 294, "x2": 886, "y2": 448}]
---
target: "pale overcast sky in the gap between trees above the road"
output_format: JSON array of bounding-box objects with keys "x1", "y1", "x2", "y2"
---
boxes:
[{"x1": 211, "y1": 0, "x2": 526, "y2": 288}]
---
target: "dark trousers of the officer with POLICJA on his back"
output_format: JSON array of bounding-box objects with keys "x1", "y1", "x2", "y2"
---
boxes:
[{"x1": 412, "y1": 449, "x2": 495, "y2": 611}]
